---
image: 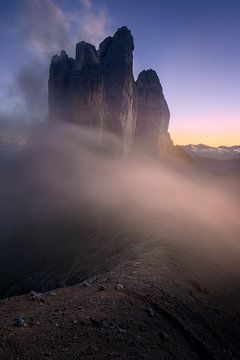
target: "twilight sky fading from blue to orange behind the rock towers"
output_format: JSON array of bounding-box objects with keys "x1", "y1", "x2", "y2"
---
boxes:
[{"x1": 0, "y1": 0, "x2": 240, "y2": 145}]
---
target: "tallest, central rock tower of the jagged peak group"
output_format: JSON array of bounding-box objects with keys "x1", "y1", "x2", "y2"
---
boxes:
[{"x1": 99, "y1": 27, "x2": 135, "y2": 151}]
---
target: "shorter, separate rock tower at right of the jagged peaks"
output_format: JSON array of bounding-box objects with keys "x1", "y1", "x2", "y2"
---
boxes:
[{"x1": 135, "y1": 69, "x2": 171, "y2": 154}]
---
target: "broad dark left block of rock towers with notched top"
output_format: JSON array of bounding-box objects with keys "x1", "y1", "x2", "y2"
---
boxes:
[{"x1": 48, "y1": 41, "x2": 103, "y2": 127}]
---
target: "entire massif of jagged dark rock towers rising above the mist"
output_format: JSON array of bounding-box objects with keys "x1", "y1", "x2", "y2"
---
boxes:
[{"x1": 49, "y1": 27, "x2": 172, "y2": 154}]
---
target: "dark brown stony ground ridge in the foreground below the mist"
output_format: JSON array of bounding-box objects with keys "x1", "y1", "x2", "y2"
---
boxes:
[{"x1": 0, "y1": 236, "x2": 240, "y2": 360}]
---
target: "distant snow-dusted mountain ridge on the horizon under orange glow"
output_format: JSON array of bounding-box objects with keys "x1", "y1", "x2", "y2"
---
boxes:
[{"x1": 181, "y1": 144, "x2": 240, "y2": 160}]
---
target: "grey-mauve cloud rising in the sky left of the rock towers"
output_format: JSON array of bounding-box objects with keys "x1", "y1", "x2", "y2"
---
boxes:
[{"x1": 0, "y1": 0, "x2": 109, "y2": 143}]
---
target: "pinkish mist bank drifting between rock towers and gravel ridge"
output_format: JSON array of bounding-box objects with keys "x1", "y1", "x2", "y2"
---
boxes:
[{"x1": 0, "y1": 123, "x2": 240, "y2": 290}]
